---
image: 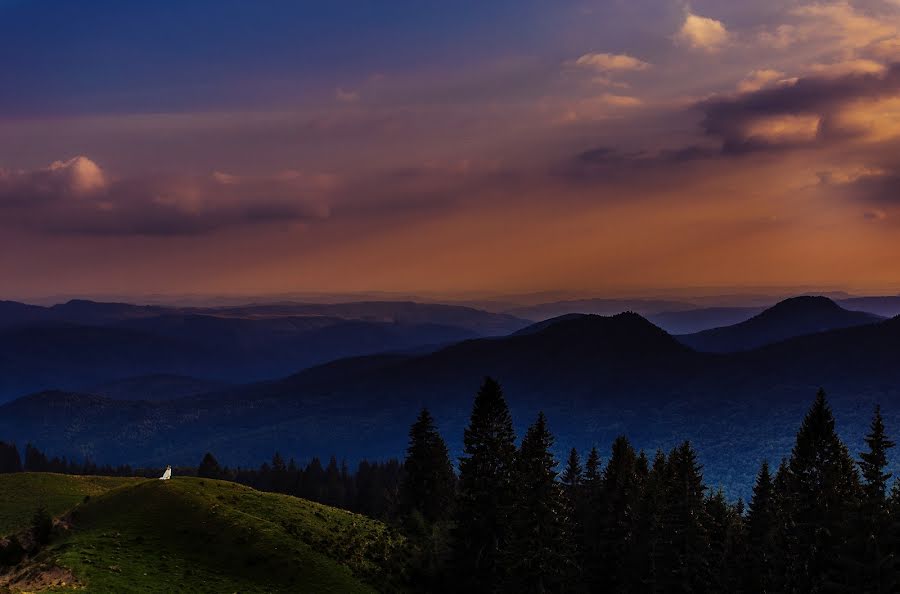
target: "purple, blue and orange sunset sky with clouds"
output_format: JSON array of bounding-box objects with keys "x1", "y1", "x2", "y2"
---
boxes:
[{"x1": 0, "y1": 0, "x2": 900, "y2": 298}]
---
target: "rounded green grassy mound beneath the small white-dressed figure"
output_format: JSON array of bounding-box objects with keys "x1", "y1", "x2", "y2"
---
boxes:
[{"x1": 0, "y1": 475, "x2": 405, "y2": 594}]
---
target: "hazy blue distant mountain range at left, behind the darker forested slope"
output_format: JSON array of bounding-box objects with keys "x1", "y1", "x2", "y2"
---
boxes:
[{"x1": 0, "y1": 300, "x2": 528, "y2": 402}]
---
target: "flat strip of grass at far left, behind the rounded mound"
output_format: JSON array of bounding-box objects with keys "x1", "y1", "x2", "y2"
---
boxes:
[{"x1": 0, "y1": 472, "x2": 142, "y2": 536}]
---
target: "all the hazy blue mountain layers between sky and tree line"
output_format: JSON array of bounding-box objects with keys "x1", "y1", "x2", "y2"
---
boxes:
[{"x1": 0, "y1": 297, "x2": 900, "y2": 496}]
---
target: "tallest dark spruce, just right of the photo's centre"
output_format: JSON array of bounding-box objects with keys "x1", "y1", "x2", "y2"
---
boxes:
[{"x1": 454, "y1": 378, "x2": 516, "y2": 593}]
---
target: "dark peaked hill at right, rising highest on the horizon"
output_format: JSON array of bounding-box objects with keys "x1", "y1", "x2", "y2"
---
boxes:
[{"x1": 678, "y1": 297, "x2": 884, "y2": 353}]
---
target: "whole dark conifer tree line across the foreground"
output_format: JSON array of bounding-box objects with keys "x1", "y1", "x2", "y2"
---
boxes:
[{"x1": 7, "y1": 378, "x2": 900, "y2": 593}]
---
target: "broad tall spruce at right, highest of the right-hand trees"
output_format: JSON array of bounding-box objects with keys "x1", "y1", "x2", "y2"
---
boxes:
[{"x1": 786, "y1": 390, "x2": 861, "y2": 592}]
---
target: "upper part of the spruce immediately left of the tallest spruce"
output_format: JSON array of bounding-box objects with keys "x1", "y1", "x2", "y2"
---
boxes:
[{"x1": 400, "y1": 409, "x2": 456, "y2": 523}]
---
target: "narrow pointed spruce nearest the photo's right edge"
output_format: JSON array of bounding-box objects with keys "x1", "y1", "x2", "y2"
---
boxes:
[{"x1": 858, "y1": 406, "x2": 897, "y2": 593}]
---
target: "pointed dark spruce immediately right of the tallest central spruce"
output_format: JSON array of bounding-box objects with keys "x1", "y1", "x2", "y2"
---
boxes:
[{"x1": 504, "y1": 413, "x2": 568, "y2": 594}]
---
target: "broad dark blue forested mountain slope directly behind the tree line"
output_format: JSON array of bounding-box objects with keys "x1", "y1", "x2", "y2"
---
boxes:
[{"x1": 0, "y1": 314, "x2": 900, "y2": 494}]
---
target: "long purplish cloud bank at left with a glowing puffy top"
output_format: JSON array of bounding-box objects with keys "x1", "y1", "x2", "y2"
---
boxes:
[{"x1": 0, "y1": 156, "x2": 335, "y2": 236}]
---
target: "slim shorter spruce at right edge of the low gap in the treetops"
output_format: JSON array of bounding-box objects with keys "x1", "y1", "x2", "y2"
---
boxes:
[{"x1": 745, "y1": 462, "x2": 778, "y2": 592}]
